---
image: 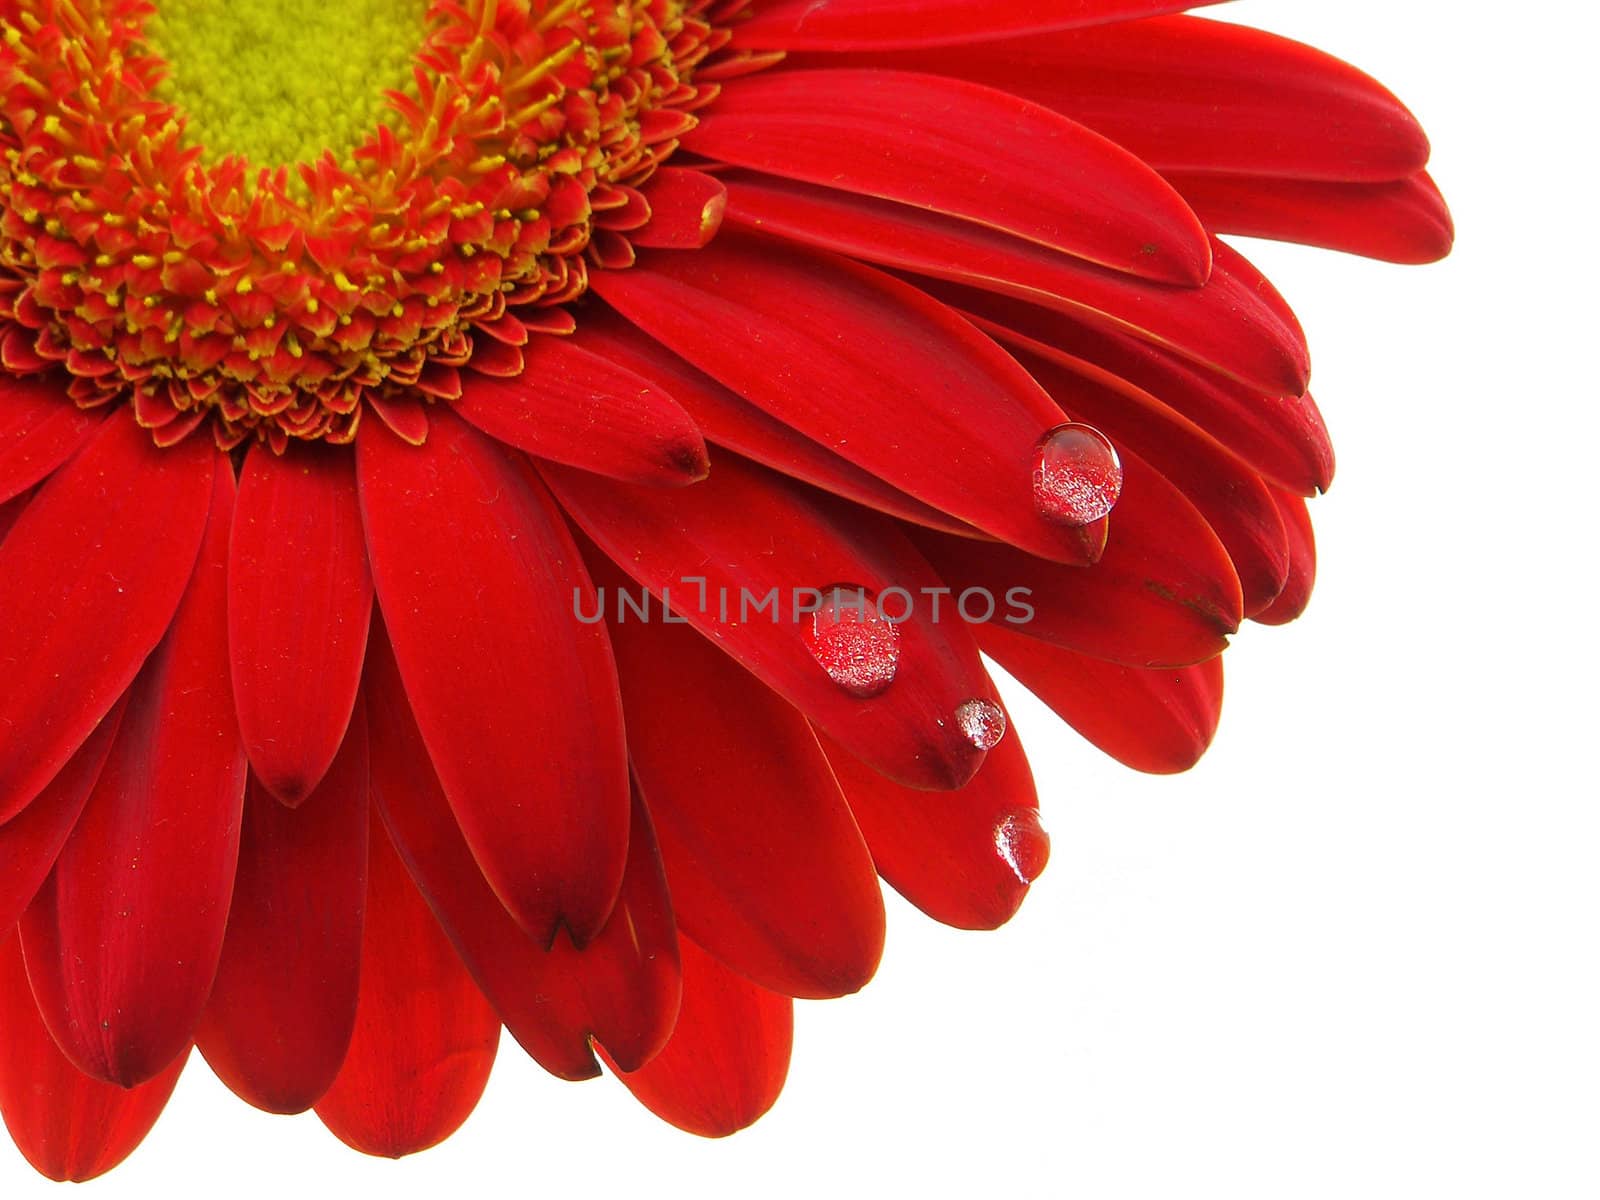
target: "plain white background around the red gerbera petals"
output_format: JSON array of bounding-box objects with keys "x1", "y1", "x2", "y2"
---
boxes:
[{"x1": 0, "y1": 0, "x2": 1600, "y2": 1200}]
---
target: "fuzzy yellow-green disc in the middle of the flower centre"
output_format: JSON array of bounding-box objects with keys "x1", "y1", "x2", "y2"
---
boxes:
[{"x1": 144, "y1": 0, "x2": 427, "y2": 166}]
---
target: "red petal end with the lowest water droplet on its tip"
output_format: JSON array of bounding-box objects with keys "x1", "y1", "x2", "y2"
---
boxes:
[{"x1": 826, "y1": 723, "x2": 1050, "y2": 930}]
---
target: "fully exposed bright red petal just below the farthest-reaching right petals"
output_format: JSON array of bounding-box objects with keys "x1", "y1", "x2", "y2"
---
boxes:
[{"x1": 683, "y1": 69, "x2": 1211, "y2": 286}]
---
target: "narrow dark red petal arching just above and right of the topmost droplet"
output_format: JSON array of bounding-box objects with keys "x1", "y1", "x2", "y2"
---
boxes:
[{"x1": 1019, "y1": 347, "x2": 1290, "y2": 616}]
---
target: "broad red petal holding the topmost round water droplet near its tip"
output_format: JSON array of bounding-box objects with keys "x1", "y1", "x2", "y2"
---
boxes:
[{"x1": 595, "y1": 234, "x2": 1102, "y2": 562}]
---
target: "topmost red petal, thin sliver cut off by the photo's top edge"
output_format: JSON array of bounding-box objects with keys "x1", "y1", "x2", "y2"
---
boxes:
[{"x1": 734, "y1": 0, "x2": 1218, "y2": 51}]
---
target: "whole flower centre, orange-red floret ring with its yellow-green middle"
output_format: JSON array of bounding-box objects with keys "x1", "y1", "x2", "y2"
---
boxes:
[{"x1": 0, "y1": 0, "x2": 713, "y2": 448}]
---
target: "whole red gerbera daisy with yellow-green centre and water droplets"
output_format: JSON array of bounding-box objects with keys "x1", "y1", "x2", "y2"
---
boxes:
[{"x1": 0, "y1": 0, "x2": 1451, "y2": 1179}]
